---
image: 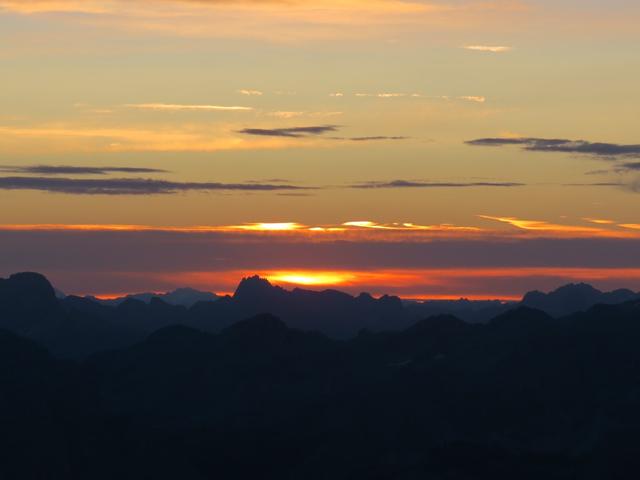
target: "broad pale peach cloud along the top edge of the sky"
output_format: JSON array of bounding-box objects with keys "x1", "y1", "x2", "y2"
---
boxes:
[{"x1": 0, "y1": 0, "x2": 470, "y2": 42}]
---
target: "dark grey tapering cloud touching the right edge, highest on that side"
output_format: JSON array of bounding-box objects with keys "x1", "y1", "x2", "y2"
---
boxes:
[{"x1": 466, "y1": 138, "x2": 640, "y2": 158}]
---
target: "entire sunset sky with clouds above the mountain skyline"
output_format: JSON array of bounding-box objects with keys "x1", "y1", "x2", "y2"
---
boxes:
[{"x1": 0, "y1": 0, "x2": 640, "y2": 299}]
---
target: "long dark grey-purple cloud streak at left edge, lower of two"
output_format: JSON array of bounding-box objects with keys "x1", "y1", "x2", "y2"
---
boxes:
[{"x1": 0, "y1": 177, "x2": 310, "y2": 195}]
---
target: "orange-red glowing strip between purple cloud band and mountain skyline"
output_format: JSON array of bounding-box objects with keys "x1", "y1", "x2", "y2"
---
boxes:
[{"x1": 63, "y1": 267, "x2": 640, "y2": 301}]
